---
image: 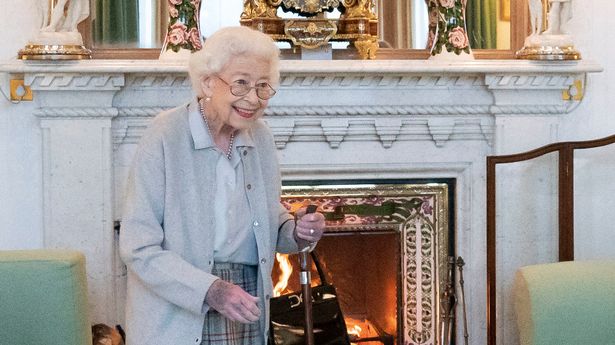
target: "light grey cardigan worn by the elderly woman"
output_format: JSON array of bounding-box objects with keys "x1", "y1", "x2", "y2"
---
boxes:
[{"x1": 120, "y1": 100, "x2": 297, "y2": 345}]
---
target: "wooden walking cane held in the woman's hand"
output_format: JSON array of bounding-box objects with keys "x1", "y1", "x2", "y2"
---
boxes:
[{"x1": 299, "y1": 205, "x2": 316, "y2": 345}]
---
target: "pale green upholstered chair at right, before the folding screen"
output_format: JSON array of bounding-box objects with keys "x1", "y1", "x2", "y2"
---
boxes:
[{"x1": 513, "y1": 260, "x2": 615, "y2": 345}]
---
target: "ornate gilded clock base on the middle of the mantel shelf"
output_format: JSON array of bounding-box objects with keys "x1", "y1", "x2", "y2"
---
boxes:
[{"x1": 240, "y1": 0, "x2": 378, "y2": 59}]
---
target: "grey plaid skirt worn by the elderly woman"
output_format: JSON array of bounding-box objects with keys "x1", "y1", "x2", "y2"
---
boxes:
[{"x1": 201, "y1": 263, "x2": 263, "y2": 345}]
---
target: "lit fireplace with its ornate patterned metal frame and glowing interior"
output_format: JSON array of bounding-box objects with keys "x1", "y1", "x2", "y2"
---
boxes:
[{"x1": 272, "y1": 180, "x2": 455, "y2": 345}]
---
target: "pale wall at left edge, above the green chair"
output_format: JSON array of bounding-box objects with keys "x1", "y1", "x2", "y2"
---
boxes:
[{"x1": 0, "y1": 0, "x2": 43, "y2": 249}]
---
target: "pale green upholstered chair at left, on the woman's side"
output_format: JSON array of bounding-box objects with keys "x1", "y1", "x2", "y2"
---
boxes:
[{"x1": 0, "y1": 250, "x2": 92, "y2": 345}]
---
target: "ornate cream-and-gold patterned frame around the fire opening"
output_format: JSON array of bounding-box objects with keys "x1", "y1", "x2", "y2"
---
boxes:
[{"x1": 282, "y1": 183, "x2": 454, "y2": 345}]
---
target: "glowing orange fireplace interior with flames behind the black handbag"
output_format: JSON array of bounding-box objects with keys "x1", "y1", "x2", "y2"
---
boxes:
[{"x1": 272, "y1": 232, "x2": 401, "y2": 345}]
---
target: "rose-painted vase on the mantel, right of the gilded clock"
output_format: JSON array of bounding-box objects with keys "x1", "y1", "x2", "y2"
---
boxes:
[{"x1": 426, "y1": 0, "x2": 474, "y2": 59}]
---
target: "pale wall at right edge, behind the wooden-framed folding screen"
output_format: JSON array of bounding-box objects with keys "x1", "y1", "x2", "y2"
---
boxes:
[{"x1": 560, "y1": 0, "x2": 615, "y2": 258}]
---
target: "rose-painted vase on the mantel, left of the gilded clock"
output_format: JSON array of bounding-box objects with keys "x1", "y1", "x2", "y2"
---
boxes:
[{"x1": 160, "y1": 0, "x2": 203, "y2": 59}]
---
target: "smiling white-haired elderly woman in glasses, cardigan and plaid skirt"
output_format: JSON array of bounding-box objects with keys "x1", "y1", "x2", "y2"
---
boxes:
[{"x1": 120, "y1": 27, "x2": 325, "y2": 345}]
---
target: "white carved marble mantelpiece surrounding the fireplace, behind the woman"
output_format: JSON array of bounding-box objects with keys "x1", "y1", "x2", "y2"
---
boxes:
[{"x1": 0, "y1": 60, "x2": 601, "y2": 344}]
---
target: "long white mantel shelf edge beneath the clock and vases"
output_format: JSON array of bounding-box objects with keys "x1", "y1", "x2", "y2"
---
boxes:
[{"x1": 0, "y1": 59, "x2": 602, "y2": 74}]
